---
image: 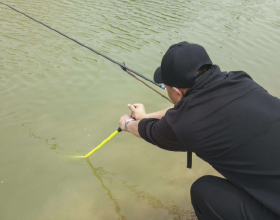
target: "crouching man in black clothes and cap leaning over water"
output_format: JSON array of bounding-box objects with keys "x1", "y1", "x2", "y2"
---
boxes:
[{"x1": 119, "y1": 42, "x2": 280, "y2": 220}]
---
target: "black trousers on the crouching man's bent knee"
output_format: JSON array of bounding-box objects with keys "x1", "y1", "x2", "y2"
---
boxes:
[{"x1": 191, "y1": 176, "x2": 280, "y2": 220}]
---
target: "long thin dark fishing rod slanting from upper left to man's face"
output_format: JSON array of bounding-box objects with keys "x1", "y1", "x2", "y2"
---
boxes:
[{"x1": 0, "y1": 2, "x2": 173, "y2": 103}]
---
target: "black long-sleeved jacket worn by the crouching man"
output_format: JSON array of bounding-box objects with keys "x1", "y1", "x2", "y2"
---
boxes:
[{"x1": 138, "y1": 66, "x2": 280, "y2": 215}]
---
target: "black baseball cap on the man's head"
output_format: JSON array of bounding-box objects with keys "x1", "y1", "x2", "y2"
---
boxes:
[{"x1": 154, "y1": 41, "x2": 212, "y2": 88}]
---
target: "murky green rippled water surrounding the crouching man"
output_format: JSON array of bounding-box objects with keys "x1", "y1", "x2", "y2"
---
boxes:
[{"x1": 0, "y1": 0, "x2": 280, "y2": 220}]
